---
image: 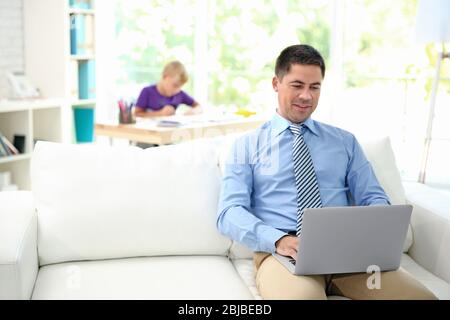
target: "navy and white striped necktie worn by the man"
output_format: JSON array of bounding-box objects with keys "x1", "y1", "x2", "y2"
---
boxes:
[{"x1": 289, "y1": 124, "x2": 322, "y2": 236}]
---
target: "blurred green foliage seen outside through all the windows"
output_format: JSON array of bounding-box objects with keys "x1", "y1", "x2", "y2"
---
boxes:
[{"x1": 115, "y1": 0, "x2": 450, "y2": 107}]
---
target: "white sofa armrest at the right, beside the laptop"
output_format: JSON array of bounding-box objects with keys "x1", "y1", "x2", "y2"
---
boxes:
[{"x1": 404, "y1": 183, "x2": 450, "y2": 283}]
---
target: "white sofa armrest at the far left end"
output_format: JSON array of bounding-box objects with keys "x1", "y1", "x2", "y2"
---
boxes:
[{"x1": 0, "y1": 191, "x2": 38, "y2": 300}]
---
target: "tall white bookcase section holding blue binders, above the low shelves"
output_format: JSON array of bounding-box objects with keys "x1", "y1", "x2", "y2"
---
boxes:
[{"x1": 23, "y1": 0, "x2": 96, "y2": 143}]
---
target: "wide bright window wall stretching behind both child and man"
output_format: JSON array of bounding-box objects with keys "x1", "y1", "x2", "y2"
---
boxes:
[{"x1": 98, "y1": 0, "x2": 450, "y2": 185}]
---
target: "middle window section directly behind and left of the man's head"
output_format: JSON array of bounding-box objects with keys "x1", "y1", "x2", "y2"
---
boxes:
[{"x1": 208, "y1": 0, "x2": 330, "y2": 110}]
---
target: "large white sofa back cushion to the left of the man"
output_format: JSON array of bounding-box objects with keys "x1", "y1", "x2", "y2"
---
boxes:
[{"x1": 32, "y1": 142, "x2": 231, "y2": 265}]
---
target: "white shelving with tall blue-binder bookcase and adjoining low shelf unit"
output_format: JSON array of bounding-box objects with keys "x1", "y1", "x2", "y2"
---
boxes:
[{"x1": 0, "y1": 0, "x2": 96, "y2": 190}]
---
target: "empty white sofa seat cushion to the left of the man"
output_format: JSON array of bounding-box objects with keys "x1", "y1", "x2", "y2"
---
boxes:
[{"x1": 32, "y1": 256, "x2": 253, "y2": 300}]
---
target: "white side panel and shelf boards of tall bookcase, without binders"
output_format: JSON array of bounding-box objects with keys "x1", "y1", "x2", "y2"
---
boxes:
[{"x1": 23, "y1": 0, "x2": 96, "y2": 143}]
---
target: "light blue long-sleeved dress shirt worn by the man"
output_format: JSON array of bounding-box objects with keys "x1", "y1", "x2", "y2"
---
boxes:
[{"x1": 217, "y1": 113, "x2": 390, "y2": 253}]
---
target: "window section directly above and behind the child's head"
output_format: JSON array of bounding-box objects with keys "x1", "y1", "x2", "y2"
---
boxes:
[{"x1": 114, "y1": 0, "x2": 196, "y2": 96}]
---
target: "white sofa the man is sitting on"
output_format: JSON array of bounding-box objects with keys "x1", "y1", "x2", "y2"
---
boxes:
[{"x1": 0, "y1": 138, "x2": 450, "y2": 299}]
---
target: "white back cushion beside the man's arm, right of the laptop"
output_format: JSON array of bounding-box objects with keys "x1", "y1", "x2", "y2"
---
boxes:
[{"x1": 361, "y1": 137, "x2": 413, "y2": 252}]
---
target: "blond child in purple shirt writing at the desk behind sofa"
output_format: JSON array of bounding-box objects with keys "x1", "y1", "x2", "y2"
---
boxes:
[{"x1": 135, "y1": 61, "x2": 200, "y2": 117}]
